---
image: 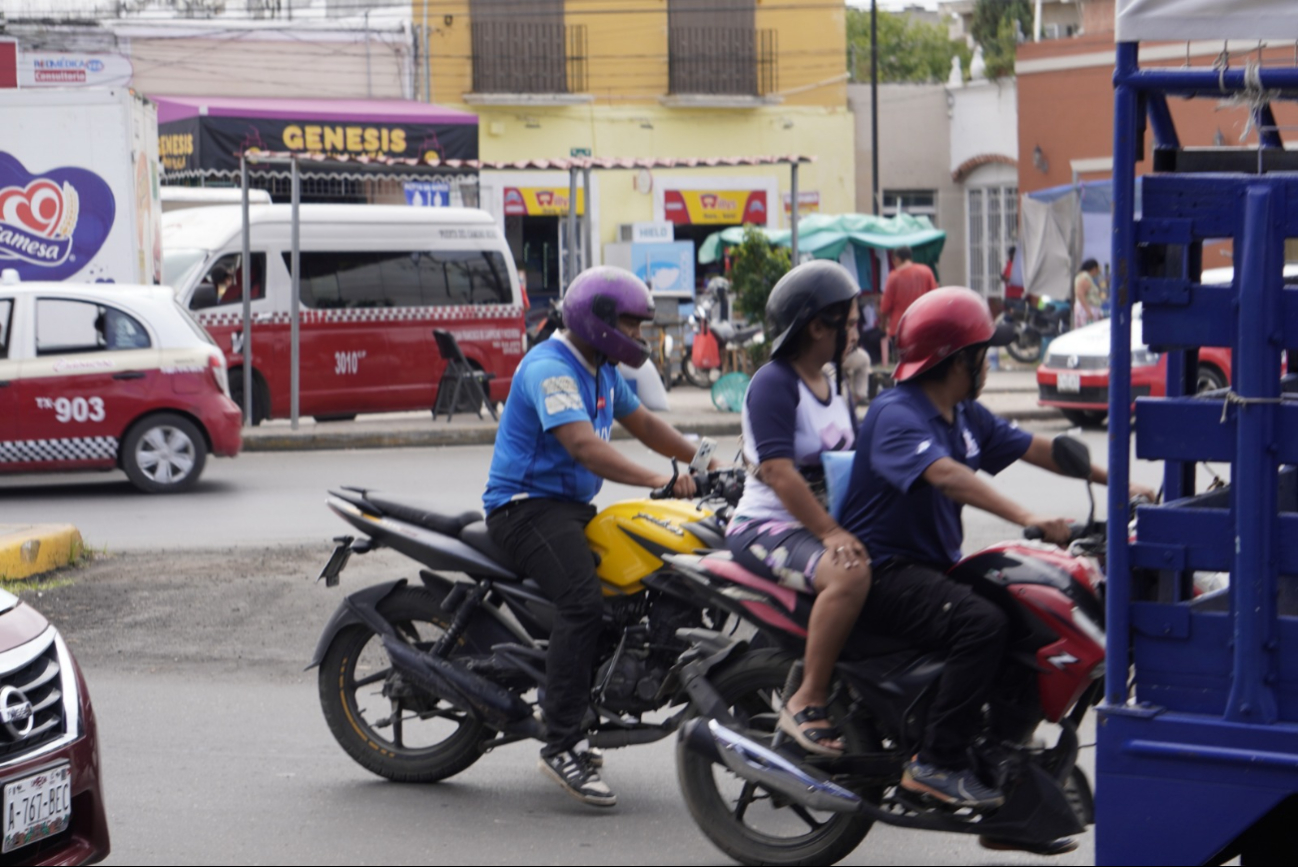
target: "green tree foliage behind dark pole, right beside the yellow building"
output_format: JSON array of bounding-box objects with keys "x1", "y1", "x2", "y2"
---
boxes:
[{"x1": 848, "y1": 8, "x2": 970, "y2": 82}]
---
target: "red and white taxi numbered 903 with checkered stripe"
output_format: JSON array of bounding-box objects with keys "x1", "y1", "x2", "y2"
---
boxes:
[{"x1": 0, "y1": 271, "x2": 241, "y2": 492}]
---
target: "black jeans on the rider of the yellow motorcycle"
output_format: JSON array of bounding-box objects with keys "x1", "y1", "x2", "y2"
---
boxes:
[{"x1": 487, "y1": 500, "x2": 604, "y2": 755}]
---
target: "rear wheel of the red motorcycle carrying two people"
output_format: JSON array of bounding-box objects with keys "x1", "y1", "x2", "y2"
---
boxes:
[{"x1": 676, "y1": 650, "x2": 883, "y2": 866}]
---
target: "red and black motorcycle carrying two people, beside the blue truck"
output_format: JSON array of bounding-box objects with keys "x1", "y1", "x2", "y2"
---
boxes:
[{"x1": 667, "y1": 437, "x2": 1105, "y2": 864}]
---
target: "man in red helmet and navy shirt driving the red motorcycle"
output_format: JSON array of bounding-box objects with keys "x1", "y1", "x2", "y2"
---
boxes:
[{"x1": 842, "y1": 287, "x2": 1147, "y2": 854}]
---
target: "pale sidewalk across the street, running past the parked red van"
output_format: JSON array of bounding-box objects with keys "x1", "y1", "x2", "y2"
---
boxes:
[{"x1": 243, "y1": 370, "x2": 1059, "y2": 452}]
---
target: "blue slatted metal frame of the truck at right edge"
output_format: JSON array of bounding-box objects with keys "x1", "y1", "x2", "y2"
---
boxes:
[{"x1": 1096, "y1": 43, "x2": 1298, "y2": 864}]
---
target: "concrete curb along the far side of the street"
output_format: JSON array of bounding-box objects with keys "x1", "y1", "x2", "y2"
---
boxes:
[{"x1": 243, "y1": 406, "x2": 1063, "y2": 452}]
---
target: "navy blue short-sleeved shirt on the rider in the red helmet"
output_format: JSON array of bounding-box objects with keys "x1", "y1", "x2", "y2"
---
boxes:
[{"x1": 841, "y1": 383, "x2": 1032, "y2": 568}]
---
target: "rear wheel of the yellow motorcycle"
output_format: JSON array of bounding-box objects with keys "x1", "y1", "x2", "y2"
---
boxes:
[{"x1": 319, "y1": 587, "x2": 489, "y2": 783}]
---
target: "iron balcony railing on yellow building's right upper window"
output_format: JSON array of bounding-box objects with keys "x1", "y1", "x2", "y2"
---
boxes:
[{"x1": 667, "y1": 27, "x2": 779, "y2": 96}]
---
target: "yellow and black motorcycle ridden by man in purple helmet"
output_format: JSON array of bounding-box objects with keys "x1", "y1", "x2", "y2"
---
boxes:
[{"x1": 310, "y1": 470, "x2": 744, "y2": 783}]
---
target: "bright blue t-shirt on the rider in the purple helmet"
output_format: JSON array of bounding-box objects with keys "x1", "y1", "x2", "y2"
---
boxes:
[{"x1": 483, "y1": 339, "x2": 640, "y2": 511}]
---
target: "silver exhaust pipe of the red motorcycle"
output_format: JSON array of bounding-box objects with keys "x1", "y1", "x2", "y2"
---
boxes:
[{"x1": 680, "y1": 718, "x2": 862, "y2": 812}]
